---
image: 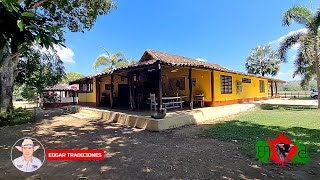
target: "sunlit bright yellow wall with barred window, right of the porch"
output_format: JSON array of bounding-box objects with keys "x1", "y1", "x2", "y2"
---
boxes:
[{"x1": 214, "y1": 71, "x2": 268, "y2": 101}]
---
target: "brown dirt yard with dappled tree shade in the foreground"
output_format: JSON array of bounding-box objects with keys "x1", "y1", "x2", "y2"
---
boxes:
[{"x1": 0, "y1": 109, "x2": 320, "y2": 179}]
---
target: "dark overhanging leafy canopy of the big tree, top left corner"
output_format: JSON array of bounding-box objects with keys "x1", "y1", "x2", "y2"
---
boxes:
[{"x1": 0, "y1": 0, "x2": 116, "y2": 52}]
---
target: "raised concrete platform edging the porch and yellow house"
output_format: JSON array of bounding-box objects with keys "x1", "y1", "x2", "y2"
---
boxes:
[{"x1": 69, "y1": 104, "x2": 256, "y2": 131}]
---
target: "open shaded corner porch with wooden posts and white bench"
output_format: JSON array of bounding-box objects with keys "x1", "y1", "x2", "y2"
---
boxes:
[{"x1": 96, "y1": 61, "x2": 213, "y2": 112}]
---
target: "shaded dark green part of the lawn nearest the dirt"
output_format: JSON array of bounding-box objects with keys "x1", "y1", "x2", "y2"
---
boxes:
[{"x1": 203, "y1": 120, "x2": 320, "y2": 157}]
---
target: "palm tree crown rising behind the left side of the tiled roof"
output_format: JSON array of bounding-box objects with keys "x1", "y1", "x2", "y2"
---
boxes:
[{"x1": 93, "y1": 48, "x2": 129, "y2": 72}]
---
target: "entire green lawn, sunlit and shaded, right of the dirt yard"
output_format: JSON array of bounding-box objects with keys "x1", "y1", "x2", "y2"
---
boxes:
[{"x1": 203, "y1": 105, "x2": 320, "y2": 157}]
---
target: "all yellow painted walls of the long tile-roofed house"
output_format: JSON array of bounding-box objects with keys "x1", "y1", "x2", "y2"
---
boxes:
[{"x1": 79, "y1": 67, "x2": 268, "y2": 105}]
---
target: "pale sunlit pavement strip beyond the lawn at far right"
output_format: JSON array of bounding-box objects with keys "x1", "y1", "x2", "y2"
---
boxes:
[{"x1": 250, "y1": 98, "x2": 318, "y2": 106}]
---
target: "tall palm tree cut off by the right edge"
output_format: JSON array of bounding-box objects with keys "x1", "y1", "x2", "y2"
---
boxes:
[{"x1": 279, "y1": 6, "x2": 320, "y2": 108}]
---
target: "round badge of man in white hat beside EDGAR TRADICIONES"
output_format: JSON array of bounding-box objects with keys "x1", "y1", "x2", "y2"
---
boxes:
[{"x1": 11, "y1": 137, "x2": 46, "y2": 172}]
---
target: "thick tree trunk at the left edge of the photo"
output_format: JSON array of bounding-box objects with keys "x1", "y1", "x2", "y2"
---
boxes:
[{"x1": 0, "y1": 54, "x2": 19, "y2": 112}]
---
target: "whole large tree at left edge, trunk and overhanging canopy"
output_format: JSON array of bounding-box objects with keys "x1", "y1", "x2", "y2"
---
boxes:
[{"x1": 0, "y1": 0, "x2": 116, "y2": 111}]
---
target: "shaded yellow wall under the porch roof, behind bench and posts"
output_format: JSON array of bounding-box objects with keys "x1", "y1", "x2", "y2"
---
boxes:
[{"x1": 162, "y1": 67, "x2": 212, "y2": 102}]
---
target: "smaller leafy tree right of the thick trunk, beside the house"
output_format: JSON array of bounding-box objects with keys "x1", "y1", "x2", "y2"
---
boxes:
[{"x1": 15, "y1": 47, "x2": 65, "y2": 93}]
